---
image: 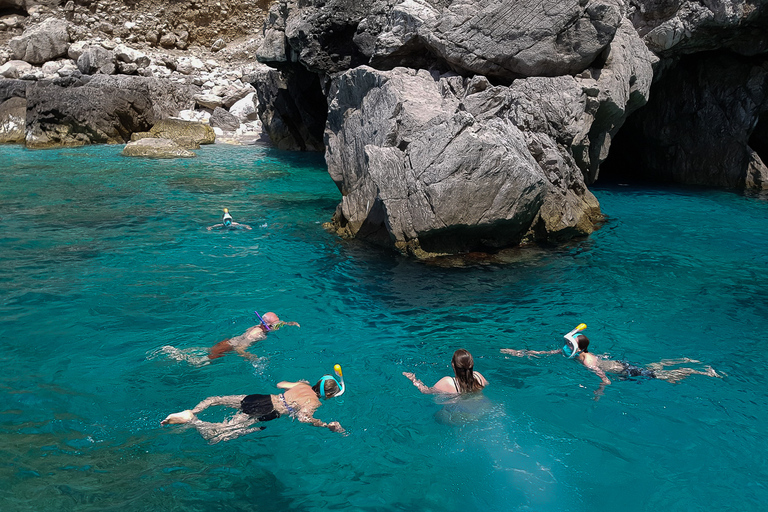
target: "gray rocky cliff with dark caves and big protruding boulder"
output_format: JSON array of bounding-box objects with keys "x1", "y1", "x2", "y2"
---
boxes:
[{"x1": 257, "y1": 0, "x2": 768, "y2": 257}]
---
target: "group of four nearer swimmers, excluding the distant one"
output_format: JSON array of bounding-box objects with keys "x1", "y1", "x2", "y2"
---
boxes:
[{"x1": 161, "y1": 312, "x2": 720, "y2": 443}]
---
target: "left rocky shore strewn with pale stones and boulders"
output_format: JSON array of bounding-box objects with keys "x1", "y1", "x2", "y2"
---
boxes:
[{"x1": 0, "y1": 0, "x2": 268, "y2": 152}]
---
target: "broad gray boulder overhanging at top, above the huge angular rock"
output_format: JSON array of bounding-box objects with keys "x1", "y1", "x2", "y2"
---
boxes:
[{"x1": 418, "y1": 0, "x2": 624, "y2": 79}]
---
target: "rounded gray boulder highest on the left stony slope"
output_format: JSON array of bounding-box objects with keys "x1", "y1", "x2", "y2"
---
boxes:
[{"x1": 8, "y1": 18, "x2": 69, "y2": 65}]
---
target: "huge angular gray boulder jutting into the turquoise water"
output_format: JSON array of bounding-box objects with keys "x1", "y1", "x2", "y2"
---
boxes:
[{"x1": 326, "y1": 66, "x2": 599, "y2": 258}]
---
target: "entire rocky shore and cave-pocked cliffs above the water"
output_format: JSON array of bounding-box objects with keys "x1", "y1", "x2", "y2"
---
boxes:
[{"x1": 0, "y1": 0, "x2": 768, "y2": 258}]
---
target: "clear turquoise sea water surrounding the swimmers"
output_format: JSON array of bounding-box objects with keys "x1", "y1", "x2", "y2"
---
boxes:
[{"x1": 0, "y1": 146, "x2": 768, "y2": 512}]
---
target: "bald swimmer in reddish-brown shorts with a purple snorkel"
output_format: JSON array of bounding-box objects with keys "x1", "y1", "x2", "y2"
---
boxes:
[{"x1": 158, "y1": 311, "x2": 301, "y2": 366}]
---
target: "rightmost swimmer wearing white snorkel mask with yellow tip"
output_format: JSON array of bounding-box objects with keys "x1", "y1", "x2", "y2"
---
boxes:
[{"x1": 501, "y1": 324, "x2": 721, "y2": 391}]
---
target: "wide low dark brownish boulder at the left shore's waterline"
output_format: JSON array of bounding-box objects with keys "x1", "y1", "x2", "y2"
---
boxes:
[{"x1": 26, "y1": 75, "x2": 196, "y2": 148}]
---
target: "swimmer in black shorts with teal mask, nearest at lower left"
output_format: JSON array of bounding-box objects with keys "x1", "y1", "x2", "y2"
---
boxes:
[{"x1": 160, "y1": 364, "x2": 345, "y2": 444}]
